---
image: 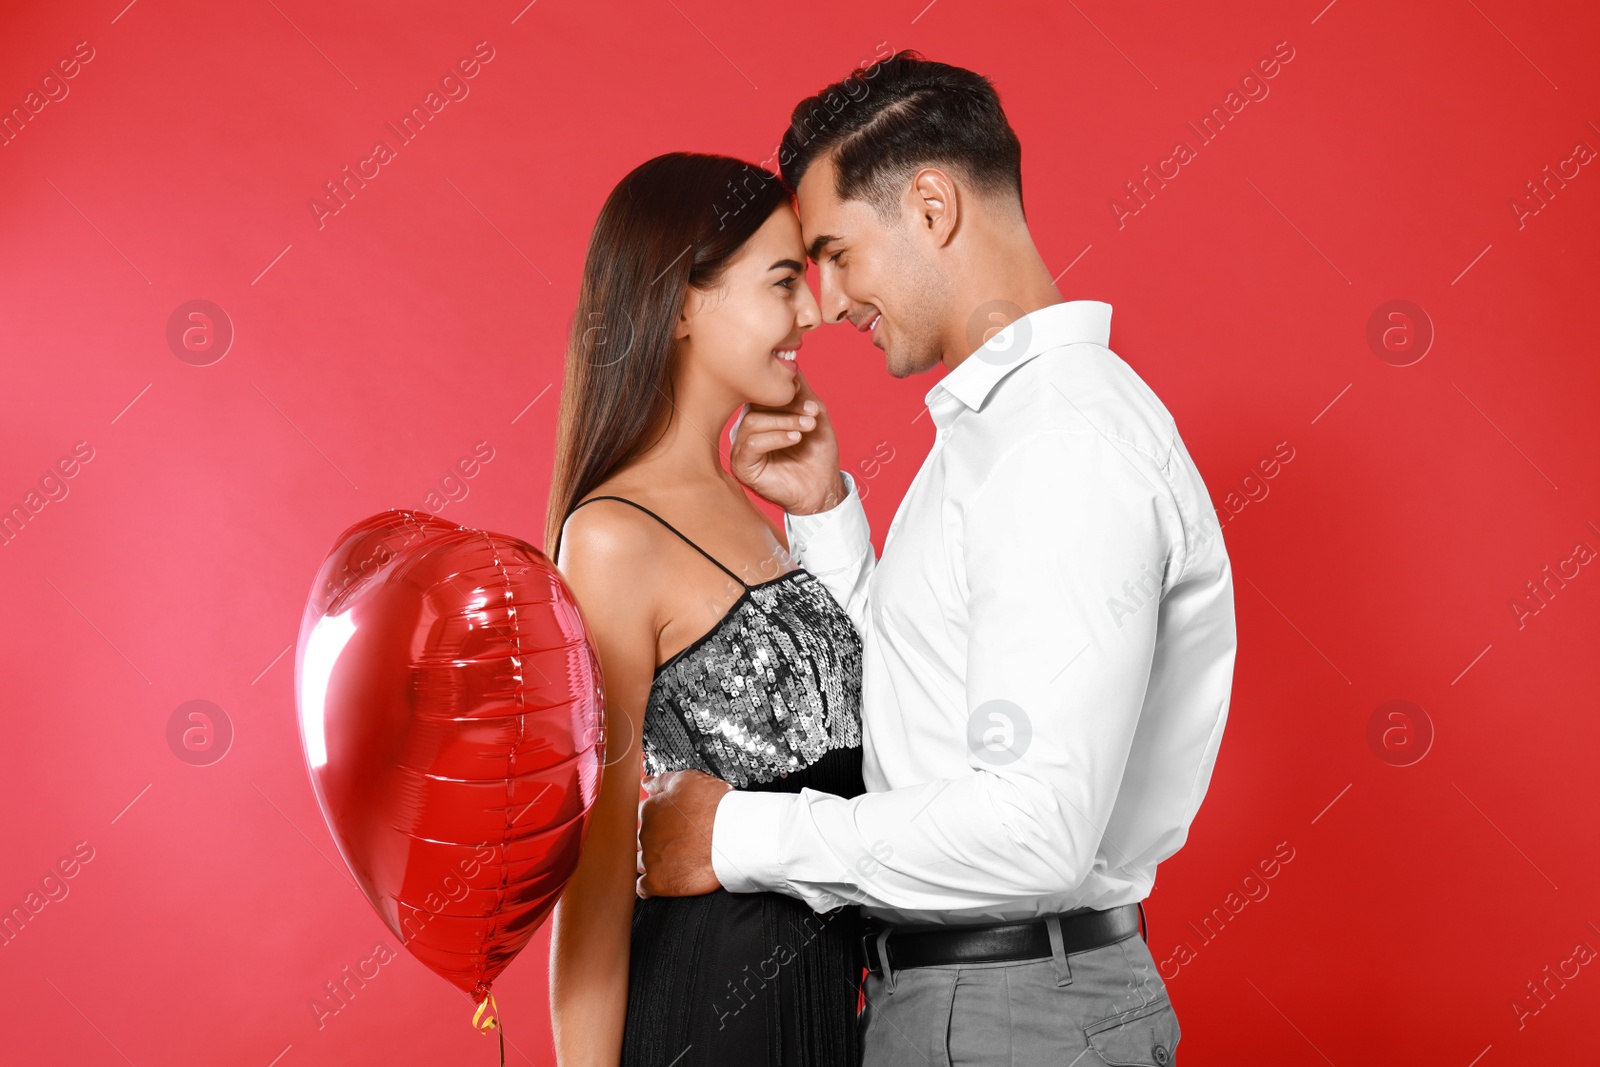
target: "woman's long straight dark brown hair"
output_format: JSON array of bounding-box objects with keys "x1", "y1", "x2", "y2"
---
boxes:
[{"x1": 544, "y1": 152, "x2": 789, "y2": 561}]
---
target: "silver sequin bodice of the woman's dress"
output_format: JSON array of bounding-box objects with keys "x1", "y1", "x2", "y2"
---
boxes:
[{"x1": 643, "y1": 572, "x2": 861, "y2": 789}]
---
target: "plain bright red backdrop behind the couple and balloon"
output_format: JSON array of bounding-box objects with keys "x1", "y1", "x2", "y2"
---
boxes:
[{"x1": 0, "y1": 0, "x2": 1600, "y2": 1067}]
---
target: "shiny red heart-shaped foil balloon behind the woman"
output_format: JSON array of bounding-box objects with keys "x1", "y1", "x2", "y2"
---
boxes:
[{"x1": 294, "y1": 510, "x2": 605, "y2": 1001}]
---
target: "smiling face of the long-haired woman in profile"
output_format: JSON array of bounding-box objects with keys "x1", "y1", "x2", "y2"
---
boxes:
[{"x1": 675, "y1": 203, "x2": 822, "y2": 406}]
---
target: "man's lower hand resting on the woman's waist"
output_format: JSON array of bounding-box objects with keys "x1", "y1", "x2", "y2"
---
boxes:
[{"x1": 635, "y1": 771, "x2": 733, "y2": 897}]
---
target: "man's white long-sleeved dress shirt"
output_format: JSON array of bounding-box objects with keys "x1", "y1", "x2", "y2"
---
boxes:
[{"x1": 712, "y1": 301, "x2": 1235, "y2": 923}]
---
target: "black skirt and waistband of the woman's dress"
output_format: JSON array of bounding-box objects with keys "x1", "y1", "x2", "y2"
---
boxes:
[{"x1": 622, "y1": 747, "x2": 866, "y2": 1067}]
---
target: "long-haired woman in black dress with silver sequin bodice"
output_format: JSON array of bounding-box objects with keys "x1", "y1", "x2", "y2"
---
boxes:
[{"x1": 546, "y1": 152, "x2": 864, "y2": 1067}]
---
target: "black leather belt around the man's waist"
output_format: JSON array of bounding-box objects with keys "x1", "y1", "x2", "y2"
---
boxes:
[{"x1": 861, "y1": 904, "x2": 1139, "y2": 974}]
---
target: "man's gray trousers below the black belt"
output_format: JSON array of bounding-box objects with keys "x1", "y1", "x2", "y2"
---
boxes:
[{"x1": 861, "y1": 934, "x2": 1179, "y2": 1067}]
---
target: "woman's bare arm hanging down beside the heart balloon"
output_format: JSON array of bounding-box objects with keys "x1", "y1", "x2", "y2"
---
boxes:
[{"x1": 550, "y1": 502, "x2": 658, "y2": 1067}]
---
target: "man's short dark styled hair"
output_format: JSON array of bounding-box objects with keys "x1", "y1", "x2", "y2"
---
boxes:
[{"x1": 778, "y1": 48, "x2": 1022, "y2": 219}]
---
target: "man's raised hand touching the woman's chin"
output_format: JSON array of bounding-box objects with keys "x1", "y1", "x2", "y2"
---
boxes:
[{"x1": 728, "y1": 373, "x2": 846, "y2": 515}]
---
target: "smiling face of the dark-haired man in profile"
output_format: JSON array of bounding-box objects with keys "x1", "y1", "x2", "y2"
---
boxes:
[{"x1": 795, "y1": 157, "x2": 949, "y2": 378}]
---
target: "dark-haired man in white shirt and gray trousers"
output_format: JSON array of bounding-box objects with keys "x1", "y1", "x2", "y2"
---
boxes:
[{"x1": 638, "y1": 53, "x2": 1235, "y2": 1067}]
